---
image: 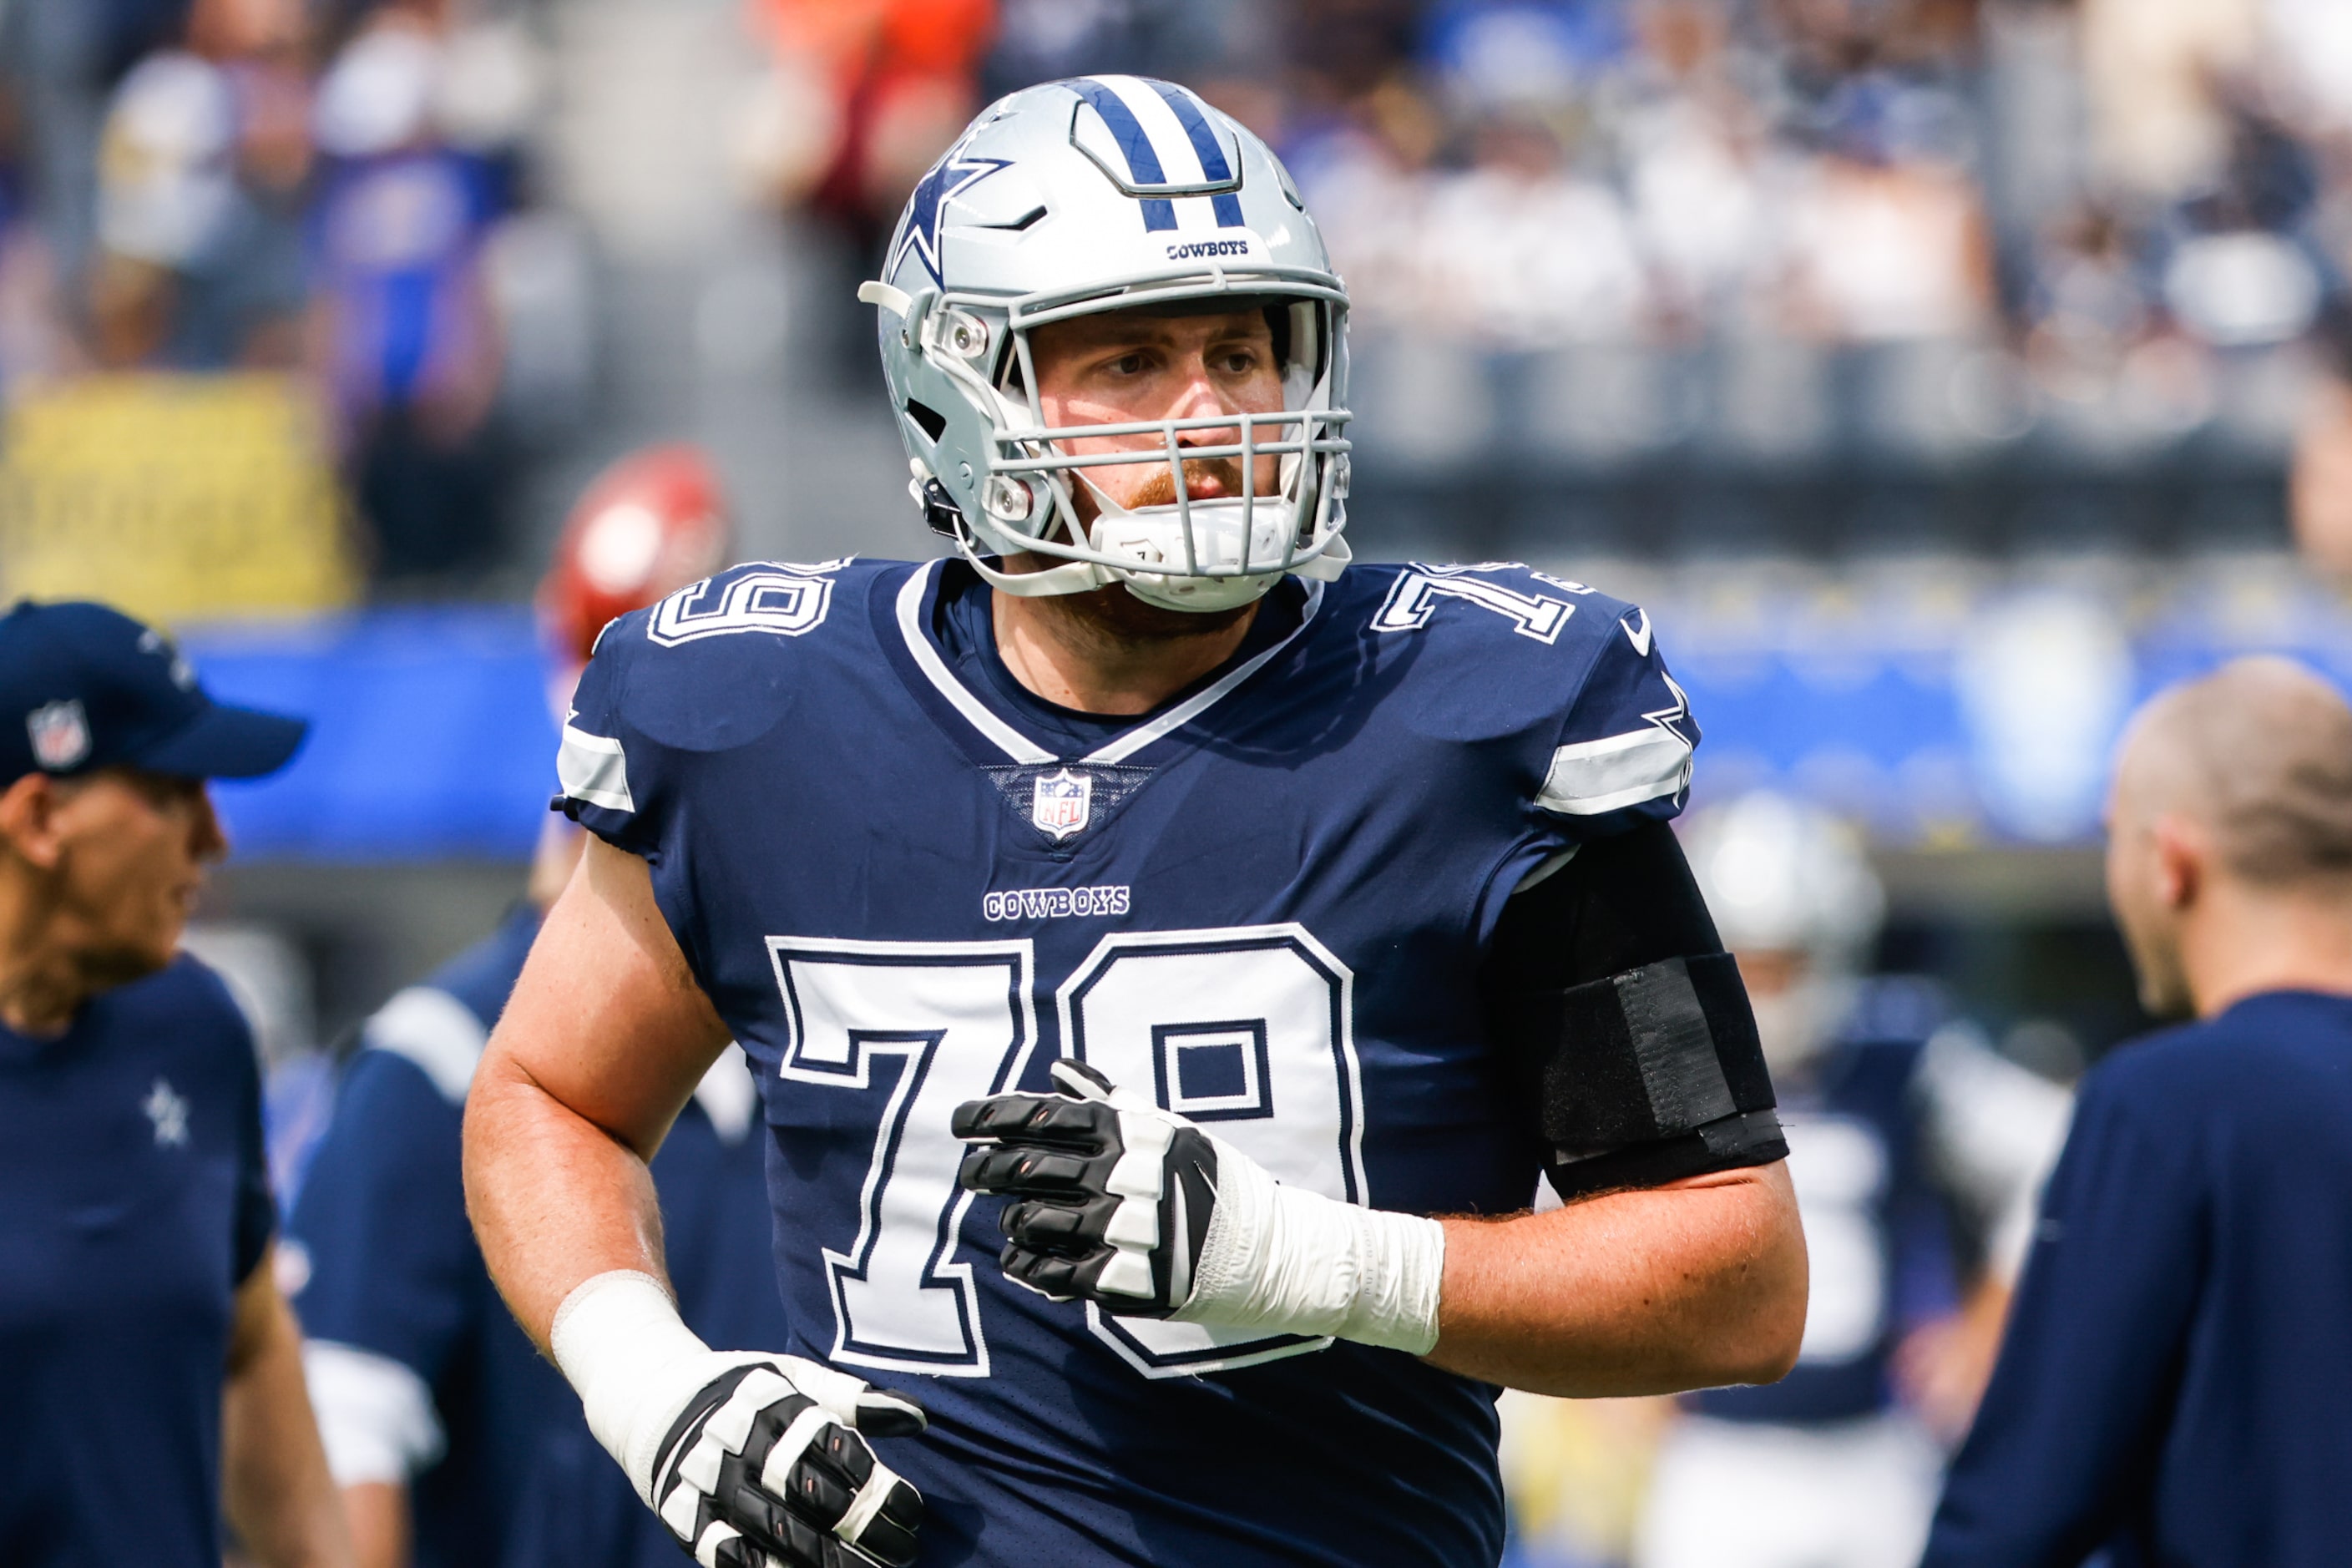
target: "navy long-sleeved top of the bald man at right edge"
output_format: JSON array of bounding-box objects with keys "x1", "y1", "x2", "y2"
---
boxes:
[{"x1": 1924, "y1": 992, "x2": 2352, "y2": 1568}]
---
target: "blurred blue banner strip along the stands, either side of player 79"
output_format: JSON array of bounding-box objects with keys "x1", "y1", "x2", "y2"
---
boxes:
[{"x1": 188, "y1": 557, "x2": 2352, "y2": 861}]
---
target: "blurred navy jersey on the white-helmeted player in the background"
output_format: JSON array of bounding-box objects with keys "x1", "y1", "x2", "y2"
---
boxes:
[{"x1": 1691, "y1": 1039, "x2": 1952, "y2": 1422}]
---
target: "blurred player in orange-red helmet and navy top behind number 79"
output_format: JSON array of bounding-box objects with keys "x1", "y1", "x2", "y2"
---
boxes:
[{"x1": 291, "y1": 447, "x2": 783, "y2": 1568}]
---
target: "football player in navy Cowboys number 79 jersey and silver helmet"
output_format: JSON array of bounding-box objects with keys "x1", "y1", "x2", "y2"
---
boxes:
[{"x1": 466, "y1": 78, "x2": 1804, "y2": 1568}]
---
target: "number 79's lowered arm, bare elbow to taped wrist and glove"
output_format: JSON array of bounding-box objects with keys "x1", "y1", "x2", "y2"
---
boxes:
[{"x1": 466, "y1": 839, "x2": 922, "y2": 1568}]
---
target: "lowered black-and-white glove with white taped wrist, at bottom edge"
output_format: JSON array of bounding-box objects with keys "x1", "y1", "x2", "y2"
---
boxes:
[{"x1": 548, "y1": 1272, "x2": 924, "y2": 1568}]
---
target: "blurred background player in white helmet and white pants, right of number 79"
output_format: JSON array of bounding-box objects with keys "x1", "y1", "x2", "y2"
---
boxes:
[{"x1": 1635, "y1": 792, "x2": 2070, "y2": 1568}]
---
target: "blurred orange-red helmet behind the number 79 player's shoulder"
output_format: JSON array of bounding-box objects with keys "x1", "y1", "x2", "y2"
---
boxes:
[{"x1": 539, "y1": 442, "x2": 726, "y2": 668}]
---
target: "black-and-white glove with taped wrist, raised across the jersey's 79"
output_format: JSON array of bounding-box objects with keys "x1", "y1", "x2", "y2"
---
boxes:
[{"x1": 950, "y1": 1058, "x2": 1444, "y2": 1357}]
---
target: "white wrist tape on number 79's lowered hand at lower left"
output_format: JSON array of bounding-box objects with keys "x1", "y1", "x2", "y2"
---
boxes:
[{"x1": 548, "y1": 1269, "x2": 774, "y2": 1507}]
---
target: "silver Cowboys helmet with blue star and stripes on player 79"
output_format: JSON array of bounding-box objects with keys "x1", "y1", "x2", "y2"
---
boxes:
[{"x1": 858, "y1": 75, "x2": 1348, "y2": 611}]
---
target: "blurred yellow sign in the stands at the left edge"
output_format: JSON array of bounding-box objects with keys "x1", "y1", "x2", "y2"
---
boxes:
[{"x1": 0, "y1": 374, "x2": 357, "y2": 625}]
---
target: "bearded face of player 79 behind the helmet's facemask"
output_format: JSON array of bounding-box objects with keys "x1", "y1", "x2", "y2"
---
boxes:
[{"x1": 1030, "y1": 311, "x2": 1296, "y2": 522}]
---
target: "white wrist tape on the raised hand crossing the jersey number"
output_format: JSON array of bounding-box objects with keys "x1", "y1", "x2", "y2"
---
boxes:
[{"x1": 1169, "y1": 1138, "x2": 1446, "y2": 1357}]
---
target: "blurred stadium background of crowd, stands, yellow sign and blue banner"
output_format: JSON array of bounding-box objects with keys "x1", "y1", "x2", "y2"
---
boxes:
[{"x1": 0, "y1": 0, "x2": 2352, "y2": 1563}]
